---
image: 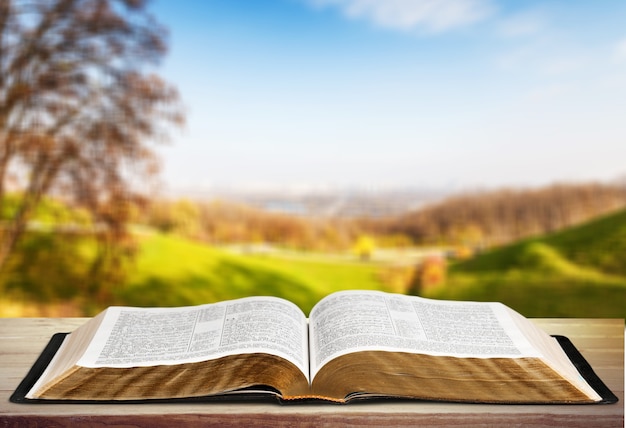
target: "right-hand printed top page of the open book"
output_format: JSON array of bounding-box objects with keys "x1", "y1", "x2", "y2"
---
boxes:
[{"x1": 309, "y1": 291, "x2": 540, "y2": 378}]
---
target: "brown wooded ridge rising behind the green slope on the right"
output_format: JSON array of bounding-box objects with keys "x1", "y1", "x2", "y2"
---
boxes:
[{"x1": 380, "y1": 183, "x2": 626, "y2": 246}]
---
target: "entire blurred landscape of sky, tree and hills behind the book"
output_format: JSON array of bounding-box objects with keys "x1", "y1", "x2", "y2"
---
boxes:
[{"x1": 0, "y1": 0, "x2": 626, "y2": 318}]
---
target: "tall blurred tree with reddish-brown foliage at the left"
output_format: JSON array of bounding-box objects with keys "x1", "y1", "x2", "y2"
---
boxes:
[{"x1": 0, "y1": 0, "x2": 183, "y2": 268}]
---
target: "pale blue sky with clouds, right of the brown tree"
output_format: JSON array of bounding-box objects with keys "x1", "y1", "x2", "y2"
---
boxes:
[{"x1": 152, "y1": 0, "x2": 626, "y2": 190}]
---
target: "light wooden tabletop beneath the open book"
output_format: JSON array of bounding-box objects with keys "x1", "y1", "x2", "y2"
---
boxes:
[{"x1": 0, "y1": 318, "x2": 624, "y2": 428}]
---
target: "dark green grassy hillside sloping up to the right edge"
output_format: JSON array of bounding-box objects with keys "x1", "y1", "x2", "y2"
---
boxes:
[{"x1": 425, "y1": 211, "x2": 626, "y2": 318}]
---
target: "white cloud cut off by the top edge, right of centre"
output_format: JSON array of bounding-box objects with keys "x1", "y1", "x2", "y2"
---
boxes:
[{"x1": 307, "y1": 0, "x2": 494, "y2": 33}]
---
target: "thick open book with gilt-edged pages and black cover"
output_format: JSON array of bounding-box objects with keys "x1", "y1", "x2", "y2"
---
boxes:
[{"x1": 17, "y1": 291, "x2": 616, "y2": 403}]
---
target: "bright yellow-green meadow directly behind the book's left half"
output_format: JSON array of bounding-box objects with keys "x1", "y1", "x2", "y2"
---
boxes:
[{"x1": 116, "y1": 234, "x2": 384, "y2": 313}]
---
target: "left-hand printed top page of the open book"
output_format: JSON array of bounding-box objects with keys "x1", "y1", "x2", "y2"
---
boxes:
[{"x1": 77, "y1": 297, "x2": 309, "y2": 379}]
